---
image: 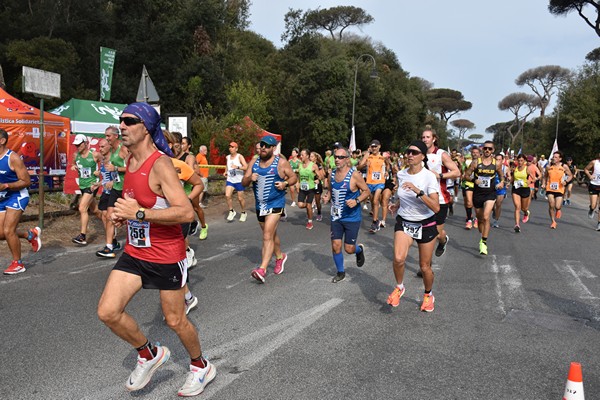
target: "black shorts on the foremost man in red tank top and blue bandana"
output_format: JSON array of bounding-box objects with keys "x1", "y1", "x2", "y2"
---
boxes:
[{"x1": 113, "y1": 253, "x2": 188, "y2": 290}]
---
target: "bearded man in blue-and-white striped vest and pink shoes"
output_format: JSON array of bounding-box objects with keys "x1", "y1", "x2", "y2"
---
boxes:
[{"x1": 242, "y1": 135, "x2": 297, "y2": 283}]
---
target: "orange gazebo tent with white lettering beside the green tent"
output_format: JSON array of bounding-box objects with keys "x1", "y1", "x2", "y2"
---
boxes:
[{"x1": 0, "y1": 88, "x2": 71, "y2": 188}]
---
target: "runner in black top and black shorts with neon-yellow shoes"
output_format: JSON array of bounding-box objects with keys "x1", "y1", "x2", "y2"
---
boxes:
[{"x1": 465, "y1": 140, "x2": 504, "y2": 255}]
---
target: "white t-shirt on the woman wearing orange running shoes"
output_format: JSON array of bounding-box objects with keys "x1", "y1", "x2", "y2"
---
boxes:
[{"x1": 398, "y1": 168, "x2": 440, "y2": 222}]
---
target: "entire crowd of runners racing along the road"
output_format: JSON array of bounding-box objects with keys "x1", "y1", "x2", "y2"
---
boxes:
[{"x1": 0, "y1": 116, "x2": 600, "y2": 396}]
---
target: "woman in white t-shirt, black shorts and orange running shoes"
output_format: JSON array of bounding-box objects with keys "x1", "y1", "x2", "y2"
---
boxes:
[{"x1": 387, "y1": 140, "x2": 440, "y2": 312}]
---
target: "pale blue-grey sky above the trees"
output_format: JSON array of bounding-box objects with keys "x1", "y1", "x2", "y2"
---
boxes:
[{"x1": 249, "y1": 0, "x2": 600, "y2": 138}]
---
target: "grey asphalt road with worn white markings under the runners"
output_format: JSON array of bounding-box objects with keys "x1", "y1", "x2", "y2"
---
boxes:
[{"x1": 0, "y1": 186, "x2": 600, "y2": 400}]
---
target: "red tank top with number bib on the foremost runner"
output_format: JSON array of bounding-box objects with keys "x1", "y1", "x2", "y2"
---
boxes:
[{"x1": 123, "y1": 151, "x2": 185, "y2": 264}]
